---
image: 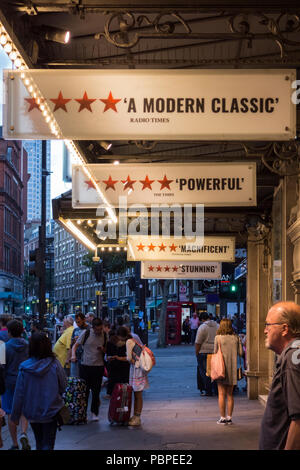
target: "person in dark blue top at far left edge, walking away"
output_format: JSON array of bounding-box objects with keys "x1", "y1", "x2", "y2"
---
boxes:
[{"x1": 2, "y1": 320, "x2": 30, "y2": 450}]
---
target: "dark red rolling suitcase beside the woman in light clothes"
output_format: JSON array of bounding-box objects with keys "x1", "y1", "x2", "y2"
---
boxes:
[{"x1": 108, "y1": 384, "x2": 132, "y2": 425}]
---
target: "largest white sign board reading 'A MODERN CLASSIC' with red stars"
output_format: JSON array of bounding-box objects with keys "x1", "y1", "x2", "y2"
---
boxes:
[{"x1": 3, "y1": 69, "x2": 296, "y2": 141}]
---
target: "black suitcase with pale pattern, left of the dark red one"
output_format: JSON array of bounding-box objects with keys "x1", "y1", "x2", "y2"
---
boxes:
[{"x1": 63, "y1": 377, "x2": 87, "y2": 424}]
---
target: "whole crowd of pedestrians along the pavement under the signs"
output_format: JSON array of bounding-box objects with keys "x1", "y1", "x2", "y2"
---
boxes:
[{"x1": 0, "y1": 302, "x2": 300, "y2": 450}]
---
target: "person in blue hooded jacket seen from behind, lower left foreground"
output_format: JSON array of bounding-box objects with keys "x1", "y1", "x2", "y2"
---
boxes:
[{"x1": 11, "y1": 333, "x2": 67, "y2": 450}]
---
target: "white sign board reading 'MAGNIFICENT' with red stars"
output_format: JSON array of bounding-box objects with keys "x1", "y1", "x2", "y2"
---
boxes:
[{"x1": 127, "y1": 236, "x2": 235, "y2": 262}]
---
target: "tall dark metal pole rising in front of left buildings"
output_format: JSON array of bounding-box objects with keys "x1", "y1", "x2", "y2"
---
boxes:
[{"x1": 39, "y1": 140, "x2": 48, "y2": 328}]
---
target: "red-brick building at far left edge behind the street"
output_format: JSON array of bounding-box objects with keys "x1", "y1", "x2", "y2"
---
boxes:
[{"x1": 0, "y1": 128, "x2": 28, "y2": 314}]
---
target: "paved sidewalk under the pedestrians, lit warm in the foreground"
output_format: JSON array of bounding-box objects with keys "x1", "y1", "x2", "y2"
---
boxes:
[{"x1": 2, "y1": 333, "x2": 264, "y2": 451}]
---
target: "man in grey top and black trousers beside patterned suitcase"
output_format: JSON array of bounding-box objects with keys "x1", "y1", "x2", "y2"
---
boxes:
[{"x1": 71, "y1": 318, "x2": 106, "y2": 421}]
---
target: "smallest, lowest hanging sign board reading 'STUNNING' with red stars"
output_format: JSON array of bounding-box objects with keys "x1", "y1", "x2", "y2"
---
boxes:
[{"x1": 141, "y1": 261, "x2": 222, "y2": 279}]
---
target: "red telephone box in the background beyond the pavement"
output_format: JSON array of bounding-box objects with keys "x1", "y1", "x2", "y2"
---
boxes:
[{"x1": 166, "y1": 302, "x2": 194, "y2": 344}]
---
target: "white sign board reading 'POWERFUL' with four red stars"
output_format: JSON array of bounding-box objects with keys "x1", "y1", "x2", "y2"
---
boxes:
[{"x1": 72, "y1": 163, "x2": 256, "y2": 209}]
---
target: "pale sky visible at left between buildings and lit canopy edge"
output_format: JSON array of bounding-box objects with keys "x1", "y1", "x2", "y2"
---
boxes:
[{"x1": 0, "y1": 46, "x2": 72, "y2": 199}]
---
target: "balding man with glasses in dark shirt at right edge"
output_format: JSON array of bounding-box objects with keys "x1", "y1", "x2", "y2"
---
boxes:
[{"x1": 259, "y1": 302, "x2": 300, "y2": 450}]
